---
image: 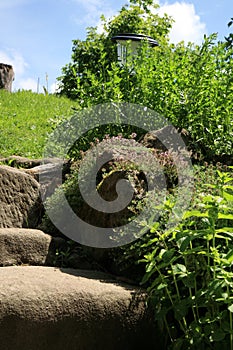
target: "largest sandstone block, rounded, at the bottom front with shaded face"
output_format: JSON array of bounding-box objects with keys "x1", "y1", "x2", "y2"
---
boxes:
[{"x1": 0, "y1": 266, "x2": 162, "y2": 350}]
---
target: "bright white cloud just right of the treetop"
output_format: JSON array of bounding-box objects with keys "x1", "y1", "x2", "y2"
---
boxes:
[{"x1": 158, "y1": 1, "x2": 207, "y2": 44}]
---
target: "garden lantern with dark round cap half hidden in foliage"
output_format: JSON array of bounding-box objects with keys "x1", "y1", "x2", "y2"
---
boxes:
[{"x1": 111, "y1": 33, "x2": 159, "y2": 66}]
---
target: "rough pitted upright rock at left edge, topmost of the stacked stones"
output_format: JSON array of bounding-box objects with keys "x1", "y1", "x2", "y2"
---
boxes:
[{"x1": 0, "y1": 165, "x2": 42, "y2": 228}]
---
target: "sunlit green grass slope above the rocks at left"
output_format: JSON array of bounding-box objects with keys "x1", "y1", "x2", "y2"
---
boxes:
[{"x1": 0, "y1": 90, "x2": 78, "y2": 158}]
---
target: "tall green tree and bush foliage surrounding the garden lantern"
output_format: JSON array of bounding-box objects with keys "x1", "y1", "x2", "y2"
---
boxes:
[{"x1": 57, "y1": 0, "x2": 233, "y2": 159}]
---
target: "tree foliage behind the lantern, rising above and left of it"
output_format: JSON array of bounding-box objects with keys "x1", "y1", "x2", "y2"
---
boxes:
[{"x1": 58, "y1": 0, "x2": 171, "y2": 98}]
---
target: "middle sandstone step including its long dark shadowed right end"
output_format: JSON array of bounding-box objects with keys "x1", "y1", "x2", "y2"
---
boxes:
[{"x1": 0, "y1": 228, "x2": 104, "y2": 270}]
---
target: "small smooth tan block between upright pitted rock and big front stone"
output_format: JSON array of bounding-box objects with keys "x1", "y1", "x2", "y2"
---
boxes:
[{"x1": 0, "y1": 228, "x2": 66, "y2": 267}]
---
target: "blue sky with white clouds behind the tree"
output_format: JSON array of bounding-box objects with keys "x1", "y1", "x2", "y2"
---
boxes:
[{"x1": 0, "y1": 0, "x2": 233, "y2": 92}]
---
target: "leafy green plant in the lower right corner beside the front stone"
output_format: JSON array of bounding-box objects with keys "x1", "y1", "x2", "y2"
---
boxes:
[{"x1": 142, "y1": 170, "x2": 233, "y2": 349}]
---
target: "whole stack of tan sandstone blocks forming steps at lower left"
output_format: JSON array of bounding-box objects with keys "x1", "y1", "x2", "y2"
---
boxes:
[{"x1": 0, "y1": 159, "x2": 163, "y2": 350}]
